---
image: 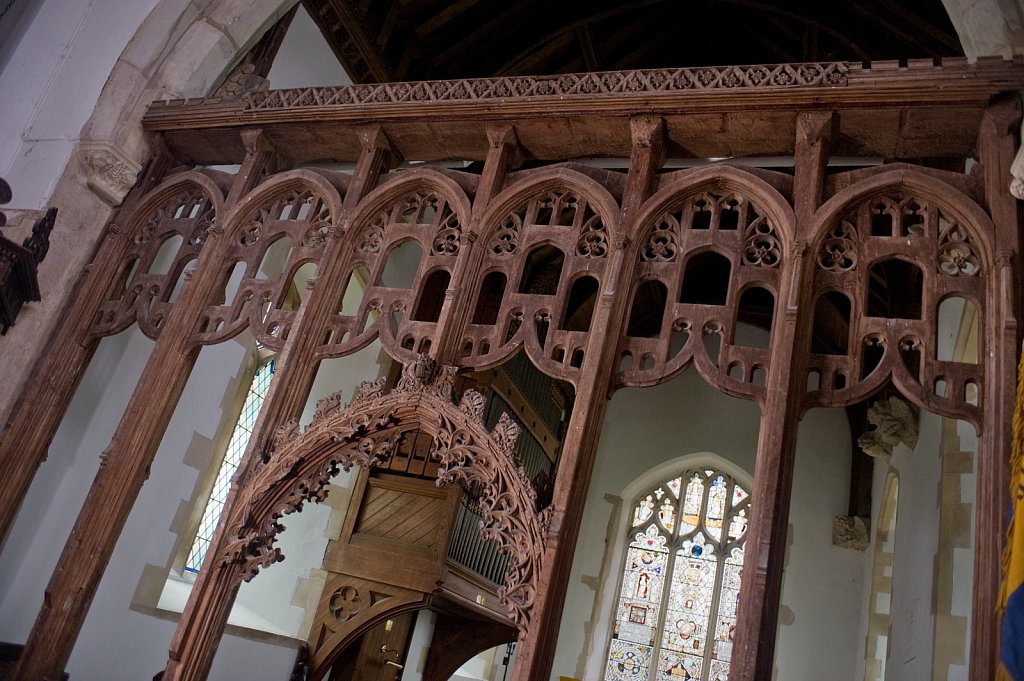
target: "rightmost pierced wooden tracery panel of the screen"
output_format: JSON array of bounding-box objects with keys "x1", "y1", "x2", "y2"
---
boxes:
[{"x1": 806, "y1": 176, "x2": 992, "y2": 424}]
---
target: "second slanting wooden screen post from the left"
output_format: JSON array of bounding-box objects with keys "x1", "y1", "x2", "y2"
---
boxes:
[{"x1": 13, "y1": 139, "x2": 272, "y2": 681}]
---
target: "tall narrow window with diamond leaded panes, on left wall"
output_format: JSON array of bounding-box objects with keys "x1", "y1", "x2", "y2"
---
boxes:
[{"x1": 185, "y1": 359, "x2": 274, "y2": 572}]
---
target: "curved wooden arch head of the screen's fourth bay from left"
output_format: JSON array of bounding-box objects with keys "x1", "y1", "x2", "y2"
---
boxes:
[{"x1": 480, "y1": 168, "x2": 618, "y2": 244}]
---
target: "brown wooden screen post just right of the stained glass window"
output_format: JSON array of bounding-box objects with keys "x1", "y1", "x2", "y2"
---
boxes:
[{"x1": 729, "y1": 113, "x2": 833, "y2": 681}]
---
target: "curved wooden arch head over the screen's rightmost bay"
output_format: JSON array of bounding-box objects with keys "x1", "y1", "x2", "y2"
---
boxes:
[{"x1": 810, "y1": 169, "x2": 995, "y2": 274}]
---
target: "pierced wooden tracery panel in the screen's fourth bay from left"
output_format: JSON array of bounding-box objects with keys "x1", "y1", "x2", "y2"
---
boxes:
[{"x1": 459, "y1": 169, "x2": 617, "y2": 381}]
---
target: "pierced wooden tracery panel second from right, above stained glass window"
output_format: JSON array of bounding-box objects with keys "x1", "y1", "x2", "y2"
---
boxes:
[{"x1": 615, "y1": 173, "x2": 786, "y2": 397}]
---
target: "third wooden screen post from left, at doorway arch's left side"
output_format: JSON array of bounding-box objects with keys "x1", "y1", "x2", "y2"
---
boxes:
[{"x1": 164, "y1": 128, "x2": 390, "y2": 681}]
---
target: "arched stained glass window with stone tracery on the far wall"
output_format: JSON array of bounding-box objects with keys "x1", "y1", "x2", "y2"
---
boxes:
[{"x1": 604, "y1": 468, "x2": 750, "y2": 681}]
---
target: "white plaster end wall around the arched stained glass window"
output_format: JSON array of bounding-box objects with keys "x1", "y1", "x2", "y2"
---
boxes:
[{"x1": 552, "y1": 371, "x2": 863, "y2": 681}]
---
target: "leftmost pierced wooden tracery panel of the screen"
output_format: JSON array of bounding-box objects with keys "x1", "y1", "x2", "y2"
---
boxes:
[{"x1": 90, "y1": 172, "x2": 222, "y2": 338}]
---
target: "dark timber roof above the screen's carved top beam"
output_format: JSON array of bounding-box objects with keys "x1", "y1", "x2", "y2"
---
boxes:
[{"x1": 303, "y1": 0, "x2": 964, "y2": 83}]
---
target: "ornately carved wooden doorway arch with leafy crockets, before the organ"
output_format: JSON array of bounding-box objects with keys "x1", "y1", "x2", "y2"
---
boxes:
[{"x1": 214, "y1": 355, "x2": 550, "y2": 631}]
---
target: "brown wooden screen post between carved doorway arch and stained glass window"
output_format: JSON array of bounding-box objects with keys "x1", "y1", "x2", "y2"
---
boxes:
[{"x1": 512, "y1": 117, "x2": 665, "y2": 681}]
